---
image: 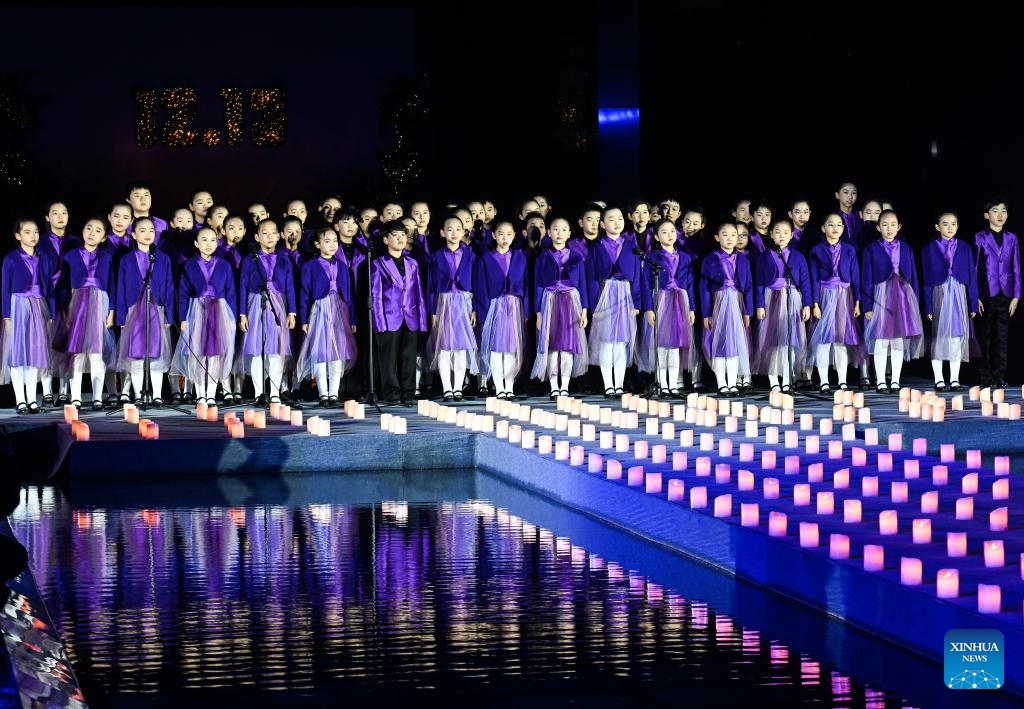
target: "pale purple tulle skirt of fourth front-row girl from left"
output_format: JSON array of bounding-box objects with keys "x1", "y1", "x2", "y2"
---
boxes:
[{"x1": 170, "y1": 298, "x2": 236, "y2": 381}]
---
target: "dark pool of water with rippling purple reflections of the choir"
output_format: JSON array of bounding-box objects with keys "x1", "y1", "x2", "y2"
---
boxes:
[{"x1": 11, "y1": 488, "x2": 921, "y2": 707}]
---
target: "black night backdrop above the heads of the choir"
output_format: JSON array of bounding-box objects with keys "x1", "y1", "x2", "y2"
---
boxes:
[{"x1": 0, "y1": 0, "x2": 1024, "y2": 377}]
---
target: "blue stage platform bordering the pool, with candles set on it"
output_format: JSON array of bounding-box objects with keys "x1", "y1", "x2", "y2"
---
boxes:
[{"x1": 0, "y1": 379, "x2": 1024, "y2": 696}]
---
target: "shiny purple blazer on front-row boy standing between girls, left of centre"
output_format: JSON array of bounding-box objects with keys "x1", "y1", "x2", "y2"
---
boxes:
[{"x1": 370, "y1": 253, "x2": 427, "y2": 332}]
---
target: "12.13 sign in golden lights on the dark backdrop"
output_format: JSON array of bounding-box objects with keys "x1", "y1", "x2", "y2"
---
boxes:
[{"x1": 133, "y1": 86, "x2": 288, "y2": 148}]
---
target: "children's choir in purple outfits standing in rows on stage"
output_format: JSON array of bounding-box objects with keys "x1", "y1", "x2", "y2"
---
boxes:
[{"x1": 0, "y1": 193, "x2": 1021, "y2": 414}]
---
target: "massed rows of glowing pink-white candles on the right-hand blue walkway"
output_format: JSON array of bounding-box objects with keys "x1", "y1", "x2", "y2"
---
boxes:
[{"x1": 421, "y1": 391, "x2": 1024, "y2": 613}]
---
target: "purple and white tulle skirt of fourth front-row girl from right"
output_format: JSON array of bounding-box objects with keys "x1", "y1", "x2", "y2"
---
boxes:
[{"x1": 751, "y1": 287, "x2": 807, "y2": 377}]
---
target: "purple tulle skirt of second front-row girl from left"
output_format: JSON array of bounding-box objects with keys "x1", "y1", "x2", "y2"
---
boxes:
[{"x1": 53, "y1": 288, "x2": 117, "y2": 377}]
